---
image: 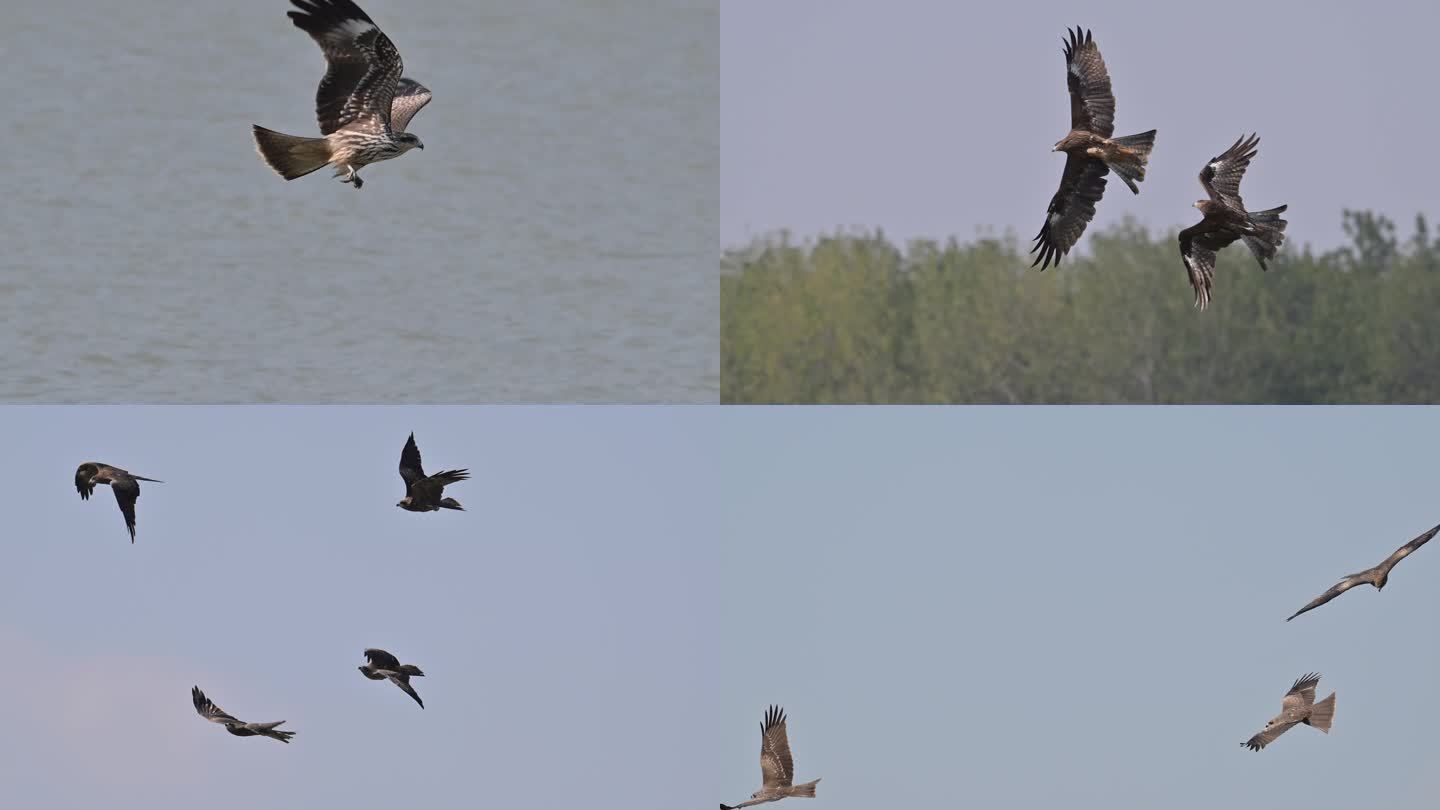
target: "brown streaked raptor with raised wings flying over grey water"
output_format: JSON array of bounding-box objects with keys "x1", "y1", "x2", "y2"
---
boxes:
[{"x1": 253, "y1": 0, "x2": 431, "y2": 189}]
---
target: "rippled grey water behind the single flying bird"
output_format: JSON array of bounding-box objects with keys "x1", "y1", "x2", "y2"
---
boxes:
[{"x1": 0, "y1": 0, "x2": 720, "y2": 402}]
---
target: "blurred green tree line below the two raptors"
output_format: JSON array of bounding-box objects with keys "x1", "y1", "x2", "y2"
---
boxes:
[{"x1": 720, "y1": 210, "x2": 1440, "y2": 404}]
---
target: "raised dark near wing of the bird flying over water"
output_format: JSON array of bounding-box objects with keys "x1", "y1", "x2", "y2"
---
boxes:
[{"x1": 288, "y1": 0, "x2": 405, "y2": 135}]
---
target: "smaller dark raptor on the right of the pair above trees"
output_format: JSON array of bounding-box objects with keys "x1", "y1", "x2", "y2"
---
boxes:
[{"x1": 1179, "y1": 135, "x2": 1289, "y2": 310}]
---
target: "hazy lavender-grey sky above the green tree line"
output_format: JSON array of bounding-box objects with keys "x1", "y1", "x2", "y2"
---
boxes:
[{"x1": 720, "y1": 0, "x2": 1440, "y2": 251}]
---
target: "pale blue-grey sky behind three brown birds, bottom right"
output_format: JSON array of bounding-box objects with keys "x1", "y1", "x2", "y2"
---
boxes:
[{"x1": 717, "y1": 406, "x2": 1440, "y2": 810}]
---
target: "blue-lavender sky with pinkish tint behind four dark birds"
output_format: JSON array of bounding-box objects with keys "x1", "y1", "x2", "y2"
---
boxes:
[{"x1": 0, "y1": 406, "x2": 720, "y2": 810}]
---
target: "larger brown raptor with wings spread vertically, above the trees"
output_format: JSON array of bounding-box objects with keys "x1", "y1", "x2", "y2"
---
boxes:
[{"x1": 1030, "y1": 27, "x2": 1155, "y2": 270}]
